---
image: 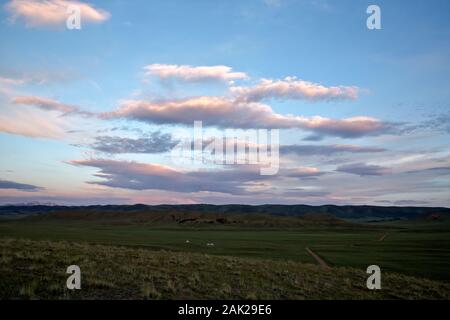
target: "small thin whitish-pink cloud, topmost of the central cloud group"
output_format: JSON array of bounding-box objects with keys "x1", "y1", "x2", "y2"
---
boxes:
[{"x1": 144, "y1": 64, "x2": 247, "y2": 82}]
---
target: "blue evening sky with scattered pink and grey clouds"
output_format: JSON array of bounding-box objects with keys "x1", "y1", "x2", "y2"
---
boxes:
[{"x1": 0, "y1": 0, "x2": 450, "y2": 207}]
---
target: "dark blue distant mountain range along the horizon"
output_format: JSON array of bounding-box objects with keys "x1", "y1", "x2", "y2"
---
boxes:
[{"x1": 0, "y1": 203, "x2": 450, "y2": 219}]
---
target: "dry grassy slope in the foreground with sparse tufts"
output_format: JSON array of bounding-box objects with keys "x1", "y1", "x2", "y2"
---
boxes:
[{"x1": 0, "y1": 239, "x2": 450, "y2": 299}]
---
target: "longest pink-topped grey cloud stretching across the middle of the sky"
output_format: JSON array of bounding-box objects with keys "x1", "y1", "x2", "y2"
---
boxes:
[{"x1": 101, "y1": 96, "x2": 391, "y2": 138}]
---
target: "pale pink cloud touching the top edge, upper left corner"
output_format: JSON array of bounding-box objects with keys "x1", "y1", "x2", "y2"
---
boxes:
[{"x1": 5, "y1": 0, "x2": 111, "y2": 27}]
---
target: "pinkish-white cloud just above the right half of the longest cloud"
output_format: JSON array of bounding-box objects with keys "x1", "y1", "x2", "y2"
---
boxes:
[{"x1": 230, "y1": 77, "x2": 359, "y2": 102}]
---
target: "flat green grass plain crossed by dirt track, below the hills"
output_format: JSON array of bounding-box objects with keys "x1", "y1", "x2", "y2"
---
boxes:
[{"x1": 0, "y1": 219, "x2": 450, "y2": 282}]
